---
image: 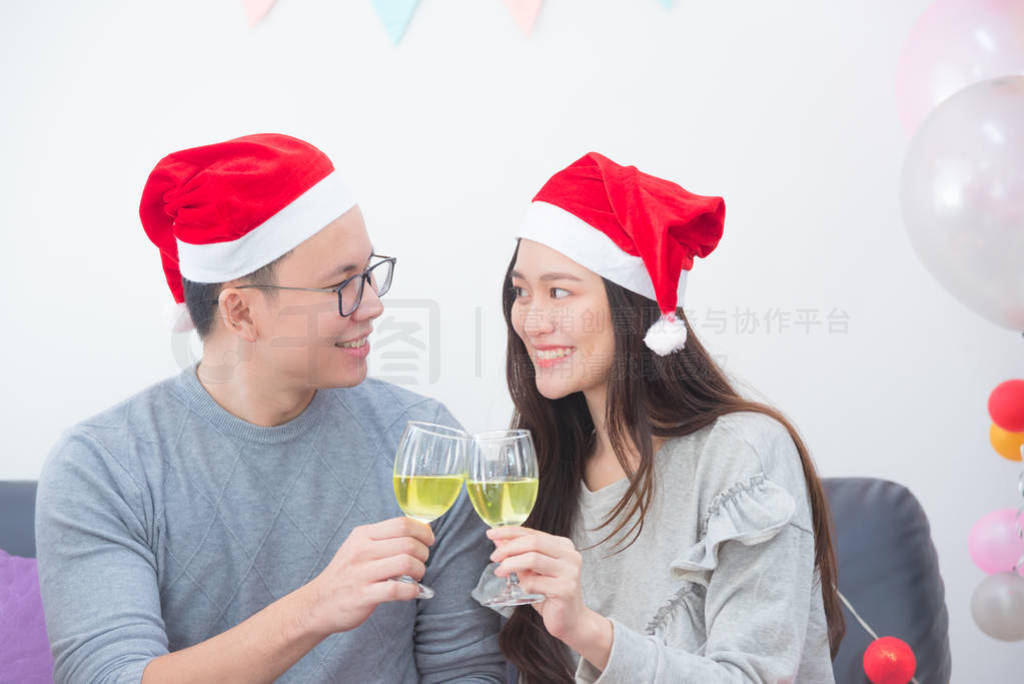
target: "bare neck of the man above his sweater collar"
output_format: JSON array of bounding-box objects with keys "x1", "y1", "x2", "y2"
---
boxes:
[{"x1": 196, "y1": 344, "x2": 316, "y2": 427}]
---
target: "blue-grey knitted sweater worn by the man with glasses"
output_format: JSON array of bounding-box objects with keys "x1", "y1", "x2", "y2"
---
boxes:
[{"x1": 36, "y1": 367, "x2": 504, "y2": 683}]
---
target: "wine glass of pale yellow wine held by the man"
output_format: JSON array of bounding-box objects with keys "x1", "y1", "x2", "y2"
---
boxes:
[{"x1": 391, "y1": 421, "x2": 469, "y2": 598}]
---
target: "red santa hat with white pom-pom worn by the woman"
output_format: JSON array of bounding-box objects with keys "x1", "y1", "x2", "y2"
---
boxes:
[{"x1": 518, "y1": 153, "x2": 725, "y2": 356}]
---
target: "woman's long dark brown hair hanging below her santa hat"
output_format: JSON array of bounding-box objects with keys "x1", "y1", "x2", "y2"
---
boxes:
[{"x1": 500, "y1": 242, "x2": 846, "y2": 684}]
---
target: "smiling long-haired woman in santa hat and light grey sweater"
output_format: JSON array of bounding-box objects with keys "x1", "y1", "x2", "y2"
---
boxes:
[{"x1": 476, "y1": 153, "x2": 844, "y2": 684}]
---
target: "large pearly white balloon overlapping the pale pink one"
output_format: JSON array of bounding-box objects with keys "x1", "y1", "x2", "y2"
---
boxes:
[{"x1": 901, "y1": 76, "x2": 1024, "y2": 331}]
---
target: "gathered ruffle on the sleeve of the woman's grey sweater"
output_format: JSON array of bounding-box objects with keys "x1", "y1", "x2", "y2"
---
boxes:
[{"x1": 672, "y1": 473, "x2": 797, "y2": 587}]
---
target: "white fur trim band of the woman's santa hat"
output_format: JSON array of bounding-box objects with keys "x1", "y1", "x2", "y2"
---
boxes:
[{"x1": 516, "y1": 202, "x2": 686, "y2": 305}]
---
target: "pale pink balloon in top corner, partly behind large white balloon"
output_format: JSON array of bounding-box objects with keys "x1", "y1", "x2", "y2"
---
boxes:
[{"x1": 896, "y1": 0, "x2": 1024, "y2": 132}]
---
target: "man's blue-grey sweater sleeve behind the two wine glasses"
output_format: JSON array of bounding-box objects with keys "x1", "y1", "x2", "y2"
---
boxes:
[{"x1": 407, "y1": 407, "x2": 505, "y2": 684}]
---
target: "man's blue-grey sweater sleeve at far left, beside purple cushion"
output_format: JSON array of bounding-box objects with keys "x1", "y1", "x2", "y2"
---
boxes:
[{"x1": 36, "y1": 428, "x2": 167, "y2": 684}]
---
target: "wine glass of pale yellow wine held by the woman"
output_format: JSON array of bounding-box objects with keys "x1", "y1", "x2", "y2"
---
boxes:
[{"x1": 466, "y1": 430, "x2": 544, "y2": 608}]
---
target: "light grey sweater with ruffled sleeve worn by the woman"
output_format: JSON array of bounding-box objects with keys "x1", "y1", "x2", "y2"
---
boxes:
[{"x1": 572, "y1": 413, "x2": 835, "y2": 684}]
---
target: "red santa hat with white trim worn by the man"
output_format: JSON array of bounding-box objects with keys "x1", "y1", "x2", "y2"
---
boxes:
[{"x1": 138, "y1": 133, "x2": 355, "y2": 331}]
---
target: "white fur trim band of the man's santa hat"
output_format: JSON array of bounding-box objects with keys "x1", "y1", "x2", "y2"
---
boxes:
[{"x1": 177, "y1": 171, "x2": 355, "y2": 283}]
